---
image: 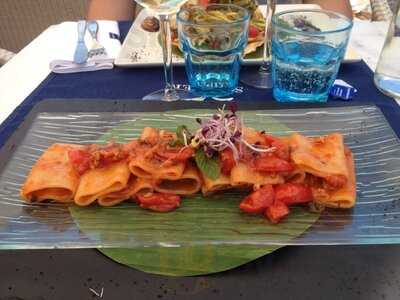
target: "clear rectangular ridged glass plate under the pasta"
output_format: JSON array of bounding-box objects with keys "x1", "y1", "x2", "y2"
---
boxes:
[{"x1": 0, "y1": 106, "x2": 400, "y2": 249}]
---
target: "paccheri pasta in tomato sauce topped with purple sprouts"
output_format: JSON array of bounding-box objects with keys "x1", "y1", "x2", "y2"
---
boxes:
[{"x1": 21, "y1": 106, "x2": 356, "y2": 223}]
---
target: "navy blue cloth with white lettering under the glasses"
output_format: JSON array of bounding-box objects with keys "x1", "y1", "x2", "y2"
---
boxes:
[{"x1": 0, "y1": 22, "x2": 400, "y2": 147}]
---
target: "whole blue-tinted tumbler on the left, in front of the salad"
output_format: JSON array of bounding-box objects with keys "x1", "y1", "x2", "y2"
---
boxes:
[{"x1": 177, "y1": 4, "x2": 249, "y2": 97}]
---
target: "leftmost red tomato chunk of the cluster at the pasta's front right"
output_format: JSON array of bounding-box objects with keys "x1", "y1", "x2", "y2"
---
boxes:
[{"x1": 239, "y1": 184, "x2": 275, "y2": 214}]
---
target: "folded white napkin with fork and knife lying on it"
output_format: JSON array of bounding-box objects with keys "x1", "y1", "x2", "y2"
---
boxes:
[{"x1": 50, "y1": 21, "x2": 121, "y2": 73}]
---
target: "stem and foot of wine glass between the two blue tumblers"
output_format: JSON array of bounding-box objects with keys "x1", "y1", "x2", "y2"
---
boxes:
[{"x1": 240, "y1": 0, "x2": 276, "y2": 89}]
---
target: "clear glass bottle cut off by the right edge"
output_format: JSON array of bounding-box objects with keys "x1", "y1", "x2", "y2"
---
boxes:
[{"x1": 374, "y1": 1, "x2": 400, "y2": 98}]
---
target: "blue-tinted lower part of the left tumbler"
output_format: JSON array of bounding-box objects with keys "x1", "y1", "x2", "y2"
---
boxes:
[{"x1": 183, "y1": 42, "x2": 242, "y2": 97}]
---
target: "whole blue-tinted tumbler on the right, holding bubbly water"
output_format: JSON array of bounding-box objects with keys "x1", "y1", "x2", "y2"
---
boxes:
[{"x1": 272, "y1": 10, "x2": 353, "y2": 102}]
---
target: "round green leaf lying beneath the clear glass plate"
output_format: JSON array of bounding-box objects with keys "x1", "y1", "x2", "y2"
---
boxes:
[{"x1": 70, "y1": 110, "x2": 319, "y2": 276}]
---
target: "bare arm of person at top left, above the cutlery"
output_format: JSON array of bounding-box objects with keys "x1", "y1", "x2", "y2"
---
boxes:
[{"x1": 87, "y1": 0, "x2": 135, "y2": 21}]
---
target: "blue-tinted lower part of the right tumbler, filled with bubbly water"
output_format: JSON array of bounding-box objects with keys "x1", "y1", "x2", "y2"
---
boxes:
[{"x1": 272, "y1": 40, "x2": 345, "y2": 102}]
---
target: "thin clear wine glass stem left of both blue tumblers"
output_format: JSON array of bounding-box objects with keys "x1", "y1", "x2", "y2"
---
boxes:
[{"x1": 160, "y1": 14, "x2": 178, "y2": 101}]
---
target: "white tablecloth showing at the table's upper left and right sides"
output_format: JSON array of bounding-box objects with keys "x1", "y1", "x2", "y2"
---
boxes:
[{"x1": 0, "y1": 20, "x2": 388, "y2": 123}]
